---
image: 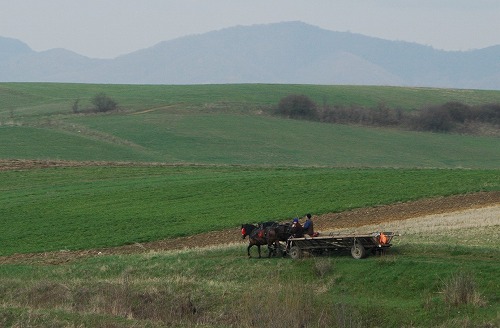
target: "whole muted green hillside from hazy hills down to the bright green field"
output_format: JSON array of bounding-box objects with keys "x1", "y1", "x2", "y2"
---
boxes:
[{"x1": 0, "y1": 84, "x2": 500, "y2": 168}]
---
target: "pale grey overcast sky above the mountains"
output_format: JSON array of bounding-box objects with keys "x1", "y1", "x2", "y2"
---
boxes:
[{"x1": 0, "y1": 0, "x2": 500, "y2": 58}]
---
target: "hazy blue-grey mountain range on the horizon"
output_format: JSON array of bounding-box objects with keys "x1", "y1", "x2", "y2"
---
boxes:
[{"x1": 0, "y1": 22, "x2": 500, "y2": 90}]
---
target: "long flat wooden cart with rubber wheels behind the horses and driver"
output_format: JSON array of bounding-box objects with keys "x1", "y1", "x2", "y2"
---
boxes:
[{"x1": 285, "y1": 232, "x2": 394, "y2": 259}]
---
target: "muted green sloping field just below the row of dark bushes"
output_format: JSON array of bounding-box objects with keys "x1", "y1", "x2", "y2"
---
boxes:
[{"x1": 0, "y1": 114, "x2": 500, "y2": 168}]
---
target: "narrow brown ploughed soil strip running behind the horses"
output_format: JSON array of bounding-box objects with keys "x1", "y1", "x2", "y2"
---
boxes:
[{"x1": 0, "y1": 191, "x2": 500, "y2": 264}]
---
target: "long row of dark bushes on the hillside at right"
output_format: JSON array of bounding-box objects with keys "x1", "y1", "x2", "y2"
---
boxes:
[{"x1": 274, "y1": 94, "x2": 500, "y2": 134}]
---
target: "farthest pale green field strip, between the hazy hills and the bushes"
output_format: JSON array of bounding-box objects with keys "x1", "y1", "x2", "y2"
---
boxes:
[{"x1": 0, "y1": 83, "x2": 500, "y2": 116}]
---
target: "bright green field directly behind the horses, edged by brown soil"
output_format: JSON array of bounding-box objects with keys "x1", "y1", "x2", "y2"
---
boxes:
[{"x1": 0, "y1": 166, "x2": 500, "y2": 255}]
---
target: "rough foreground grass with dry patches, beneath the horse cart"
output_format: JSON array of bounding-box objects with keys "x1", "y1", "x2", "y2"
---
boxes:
[{"x1": 0, "y1": 220, "x2": 500, "y2": 327}]
